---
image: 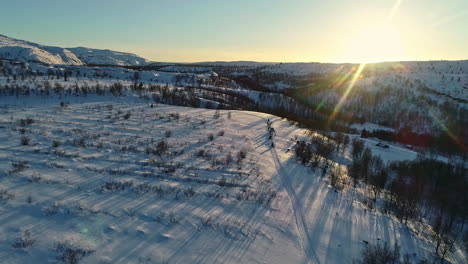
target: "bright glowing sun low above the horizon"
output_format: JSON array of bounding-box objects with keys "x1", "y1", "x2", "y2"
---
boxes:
[{"x1": 345, "y1": 23, "x2": 404, "y2": 63}]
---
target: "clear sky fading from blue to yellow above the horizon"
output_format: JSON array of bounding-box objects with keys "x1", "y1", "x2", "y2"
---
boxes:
[{"x1": 0, "y1": 0, "x2": 468, "y2": 62}]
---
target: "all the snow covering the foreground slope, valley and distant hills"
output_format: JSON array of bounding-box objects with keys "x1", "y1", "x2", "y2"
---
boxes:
[{"x1": 0, "y1": 36, "x2": 468, "y2": 263}]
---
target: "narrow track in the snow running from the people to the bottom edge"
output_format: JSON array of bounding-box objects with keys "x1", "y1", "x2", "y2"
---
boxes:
[{"x1": 271, "y1": 145, "x2": 320, "y2": 264}]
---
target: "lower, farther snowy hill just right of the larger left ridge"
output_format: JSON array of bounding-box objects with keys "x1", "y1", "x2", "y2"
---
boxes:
[{"x1": 68, "y1": 47, "x2": 148, "y2": 66}]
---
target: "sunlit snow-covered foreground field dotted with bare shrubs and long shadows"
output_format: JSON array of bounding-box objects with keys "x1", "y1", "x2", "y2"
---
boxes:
[{"x1": 0, "y1": 97, "x2": 464, "y2": 263}]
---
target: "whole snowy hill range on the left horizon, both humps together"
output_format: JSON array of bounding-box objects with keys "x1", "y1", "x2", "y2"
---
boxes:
[{"x1": 0, "y1": 35, "x2": 148, "y2": 66}]
